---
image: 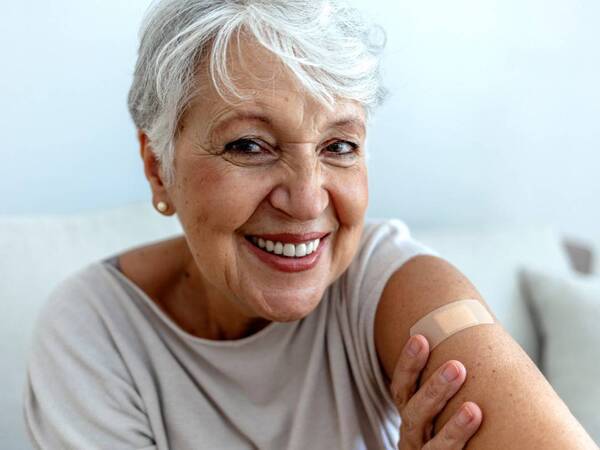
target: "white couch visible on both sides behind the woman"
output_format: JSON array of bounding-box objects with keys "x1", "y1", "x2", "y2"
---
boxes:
[{"x1": 0, "y1": 204, "x2": 571, "y2": 450}]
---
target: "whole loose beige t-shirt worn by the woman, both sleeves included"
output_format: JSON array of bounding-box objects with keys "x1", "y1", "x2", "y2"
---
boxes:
[{"x1": 23, "y1": 220, "x2": 439, "y2": 450}]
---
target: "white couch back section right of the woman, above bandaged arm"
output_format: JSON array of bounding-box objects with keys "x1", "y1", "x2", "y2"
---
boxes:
[{"x1": 412, "y1": 225, "x2": 571, "y2": 364}]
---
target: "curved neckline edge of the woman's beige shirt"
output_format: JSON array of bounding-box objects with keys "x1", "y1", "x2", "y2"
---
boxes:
[{"x1": 99, "y1": 261, "x2": 286, "y2": 348}]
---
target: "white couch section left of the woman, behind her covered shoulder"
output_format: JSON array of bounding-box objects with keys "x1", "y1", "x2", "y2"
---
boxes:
[{"x1": 0, "y1": 203, "x2": 181, "y2": 449}]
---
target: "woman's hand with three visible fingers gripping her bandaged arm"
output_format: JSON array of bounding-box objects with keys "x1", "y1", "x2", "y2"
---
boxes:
[{"x1": 391, "y1": 335, "x2": 483, "y2": 450}]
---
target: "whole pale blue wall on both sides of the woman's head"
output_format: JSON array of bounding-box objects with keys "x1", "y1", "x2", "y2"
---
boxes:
[{"x1": 0, "y1": 0, "x2": 600, "y2": 248}]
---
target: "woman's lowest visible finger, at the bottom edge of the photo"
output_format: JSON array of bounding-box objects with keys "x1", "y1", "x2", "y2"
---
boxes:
[{"x1": 423, "y1": 402, "x2": 483, "y2": 450}]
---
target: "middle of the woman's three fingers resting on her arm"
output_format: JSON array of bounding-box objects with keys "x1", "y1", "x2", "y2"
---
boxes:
[{"x1": 400, "y1": 360, "x2": 467, "y2": 445}]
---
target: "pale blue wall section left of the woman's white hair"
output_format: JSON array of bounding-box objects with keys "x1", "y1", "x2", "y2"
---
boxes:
[{"x1": 0, "y1": 0, "x2": 149, "y2": 214}]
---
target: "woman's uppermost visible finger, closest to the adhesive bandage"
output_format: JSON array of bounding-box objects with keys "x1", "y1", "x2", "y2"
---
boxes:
[{"x1": 390, "y1": 334, "x2": 429, "y2": 411}]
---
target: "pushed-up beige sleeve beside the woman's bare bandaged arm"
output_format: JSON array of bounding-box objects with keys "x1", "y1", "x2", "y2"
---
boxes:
[{"x1": 340, "y1": 220, "x2": 440, "y2": 440}]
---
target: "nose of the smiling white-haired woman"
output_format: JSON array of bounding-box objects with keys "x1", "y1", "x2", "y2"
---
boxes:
[{"x1": 270, "y1": 158, "x2": 329, "y2": 221}]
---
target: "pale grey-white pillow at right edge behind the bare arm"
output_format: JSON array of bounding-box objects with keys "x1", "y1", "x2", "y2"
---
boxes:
[{"x1": 520, "y1": 269, "x2": 600, "y2": 443}]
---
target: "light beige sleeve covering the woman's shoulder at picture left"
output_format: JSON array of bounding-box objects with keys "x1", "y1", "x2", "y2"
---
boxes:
[{"x1": 22, "y1": 278, "x2": 156, "y2": 450}]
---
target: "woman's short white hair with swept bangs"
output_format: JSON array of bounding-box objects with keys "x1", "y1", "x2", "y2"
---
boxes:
[{"x1": 128, "y1": 0, "x2": 387, "y2": 185}]
